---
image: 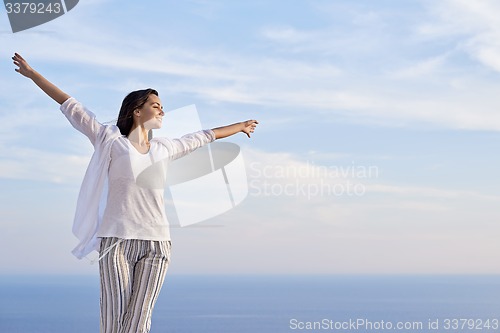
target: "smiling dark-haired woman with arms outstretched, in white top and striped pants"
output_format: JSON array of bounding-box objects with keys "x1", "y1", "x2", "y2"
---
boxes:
[{"x1": 12, "y1": 53, "x2": 258, "y2": 333}]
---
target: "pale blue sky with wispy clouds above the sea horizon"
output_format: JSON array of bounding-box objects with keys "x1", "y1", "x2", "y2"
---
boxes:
[{"x1": 0, "y1": 0, "x2": 500, "y2": 274}]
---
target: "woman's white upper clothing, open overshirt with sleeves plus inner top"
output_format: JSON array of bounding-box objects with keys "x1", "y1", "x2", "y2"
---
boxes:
[{"x1": 60, "y1": 97, "x2": 215, "y2": 259}]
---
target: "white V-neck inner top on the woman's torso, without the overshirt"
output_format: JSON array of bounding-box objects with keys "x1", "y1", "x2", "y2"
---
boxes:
[{"x1": 97, "y1": 137, "x2": 170, "y2": 240}]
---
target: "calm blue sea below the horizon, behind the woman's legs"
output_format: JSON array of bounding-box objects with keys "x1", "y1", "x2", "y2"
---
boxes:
[{"x1": 0, "y1": 274, "x2": 500, "y2": 333}]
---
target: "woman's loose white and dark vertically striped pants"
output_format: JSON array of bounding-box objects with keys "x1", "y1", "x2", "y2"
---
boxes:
[{"x1": 99, "y1": 237, "x2": 171, "y2": 333}]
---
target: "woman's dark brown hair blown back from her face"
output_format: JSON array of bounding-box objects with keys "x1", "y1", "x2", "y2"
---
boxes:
[{"x1": 116, "y1": 88, "x2": 158, "y2": 136}]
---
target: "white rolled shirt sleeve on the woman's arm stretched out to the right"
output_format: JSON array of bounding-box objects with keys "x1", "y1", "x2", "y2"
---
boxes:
[{"x1": 154, "y1": 130, "x2": 215, "y2": 160}]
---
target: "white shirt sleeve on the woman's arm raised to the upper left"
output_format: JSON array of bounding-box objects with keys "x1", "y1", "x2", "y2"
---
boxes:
[{"x1": 60, "y1": 97, "x2": 103, "y2": 146}]
